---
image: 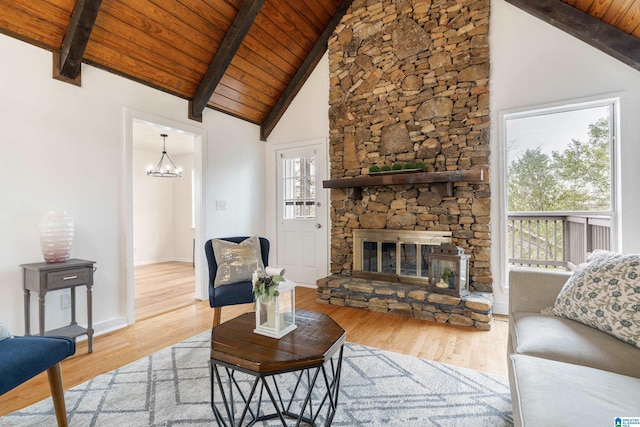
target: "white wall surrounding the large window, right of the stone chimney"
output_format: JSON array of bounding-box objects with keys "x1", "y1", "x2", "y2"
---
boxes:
[{"x1": 489, "y1": 0, "x2": 640, "y2": 311}]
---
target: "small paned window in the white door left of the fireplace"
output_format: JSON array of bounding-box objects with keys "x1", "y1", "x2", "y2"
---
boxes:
[{"x1": 282, "y1": 155, "x2": 316, "y2": 219}]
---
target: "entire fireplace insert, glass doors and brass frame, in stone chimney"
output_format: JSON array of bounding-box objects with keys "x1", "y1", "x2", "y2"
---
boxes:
[{"x1": 352, "y1": 229, "x2": 451, "y2": 287}]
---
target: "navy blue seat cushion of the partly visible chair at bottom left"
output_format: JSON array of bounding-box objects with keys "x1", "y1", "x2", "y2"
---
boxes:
[{"x1": 0, "y1": 336, "x2": 76, "y2": 395}]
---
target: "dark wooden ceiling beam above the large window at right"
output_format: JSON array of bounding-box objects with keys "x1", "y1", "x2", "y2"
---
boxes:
[{"x1": 506, "y1": 0, "x2": 640, "y2": 71}]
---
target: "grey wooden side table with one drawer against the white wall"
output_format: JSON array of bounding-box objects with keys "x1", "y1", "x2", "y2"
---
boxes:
[{"x1": 20, "y1": 258, "x2": 95, "y2": 353}]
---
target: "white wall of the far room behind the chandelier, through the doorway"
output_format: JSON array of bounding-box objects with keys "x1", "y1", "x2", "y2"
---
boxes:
[{"x1": 132, "y1": 149, "x2": 194, "y2": 265}]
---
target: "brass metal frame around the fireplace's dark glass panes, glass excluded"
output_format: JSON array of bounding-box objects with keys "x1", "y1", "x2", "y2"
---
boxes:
[{"x1": 351, "y1": 229, "x2": 452, "y2": 287}]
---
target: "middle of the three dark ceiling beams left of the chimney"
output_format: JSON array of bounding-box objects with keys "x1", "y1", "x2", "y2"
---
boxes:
[{"x1": 189, "y1": 0, "x2": 264, "y2": 122}]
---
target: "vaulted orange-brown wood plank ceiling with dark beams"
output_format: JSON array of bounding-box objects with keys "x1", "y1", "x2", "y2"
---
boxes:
[{"x1": 0, "y1": 0, "x2": 640, "y2": 140}]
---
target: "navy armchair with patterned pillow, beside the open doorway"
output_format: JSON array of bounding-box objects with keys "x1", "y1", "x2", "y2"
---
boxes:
[{"x1": 204, "y1": 237, "x2": 269, "y2": 328}]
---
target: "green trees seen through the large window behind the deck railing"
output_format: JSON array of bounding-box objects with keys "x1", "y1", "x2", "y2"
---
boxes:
[{"x1": 507, "y1": 114, "x2": 611, "y2": 266}]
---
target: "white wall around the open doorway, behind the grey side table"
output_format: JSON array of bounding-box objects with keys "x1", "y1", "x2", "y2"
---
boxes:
[{"x1": 0, "y1": 35, "x2": 265, "y2": 334}]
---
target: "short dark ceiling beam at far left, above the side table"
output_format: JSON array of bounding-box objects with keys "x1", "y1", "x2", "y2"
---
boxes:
[{"x1": 54, "y1": 0, "x2": 102, "y2": 81}]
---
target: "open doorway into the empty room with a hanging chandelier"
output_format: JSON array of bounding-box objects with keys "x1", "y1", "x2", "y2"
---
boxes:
[{"x1": 125, "y1": 111, "x2": 206, "y2": 324}]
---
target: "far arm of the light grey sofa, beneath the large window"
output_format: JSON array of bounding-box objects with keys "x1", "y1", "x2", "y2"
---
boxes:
[{"x1": 509, "y1": 268, "x2": 571, "y2": 313}]
